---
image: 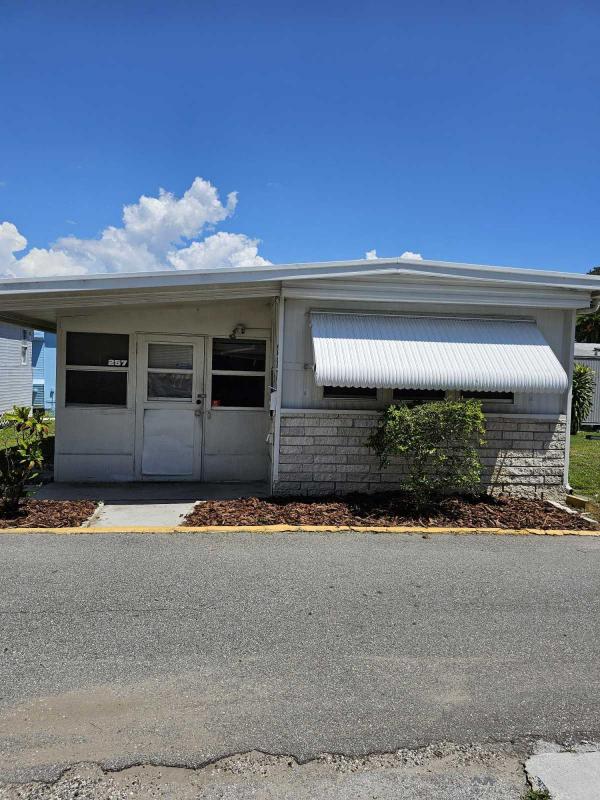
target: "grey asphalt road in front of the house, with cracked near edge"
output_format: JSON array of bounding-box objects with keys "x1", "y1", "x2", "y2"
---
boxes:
[{"x1": 0, "y1": 534, "x2": 600, "y2": 780}]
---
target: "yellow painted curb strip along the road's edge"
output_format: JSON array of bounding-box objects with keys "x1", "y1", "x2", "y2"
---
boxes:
[{"x1": 0, "y1": 525, "x2": 600, "y2": 536}]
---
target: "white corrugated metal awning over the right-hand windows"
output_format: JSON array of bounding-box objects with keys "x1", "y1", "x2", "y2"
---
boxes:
[{"x1": 310, "y1": 311, "x2": 569, "y2": 393}]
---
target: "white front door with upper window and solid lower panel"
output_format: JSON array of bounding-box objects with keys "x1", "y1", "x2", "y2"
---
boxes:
[{"x1": 136, "y1": 335, "x2": 204, "y2": 480}]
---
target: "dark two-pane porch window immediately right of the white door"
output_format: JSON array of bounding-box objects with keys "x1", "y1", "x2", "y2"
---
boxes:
[{"x1": 211, "y1": 339, "x2": 267, "y2": 408}]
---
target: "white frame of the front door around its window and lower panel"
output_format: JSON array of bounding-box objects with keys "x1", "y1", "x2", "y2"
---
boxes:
[{"x1": 134, "y1": 332, "x2": 207, "y2": 482}]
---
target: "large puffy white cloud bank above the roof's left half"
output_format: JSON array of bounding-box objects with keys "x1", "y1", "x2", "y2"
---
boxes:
[{"x1": 0, "y1": 178, "x2": 269, "y2": 277}]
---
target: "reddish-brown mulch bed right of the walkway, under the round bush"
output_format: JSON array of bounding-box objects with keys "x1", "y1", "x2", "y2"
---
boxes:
[{"x1": 183, "y1": 494, "x2": 600, "y2": 530}]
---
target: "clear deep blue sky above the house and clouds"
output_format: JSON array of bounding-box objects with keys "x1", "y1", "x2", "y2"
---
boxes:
[{"x1": 0, "y1": 0, "x2": 600, "y2": 274}]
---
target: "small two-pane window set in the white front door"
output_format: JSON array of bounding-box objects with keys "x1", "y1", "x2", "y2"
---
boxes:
[{"x1": 148, "y1": 342, "x2": 194, "y2": 400}]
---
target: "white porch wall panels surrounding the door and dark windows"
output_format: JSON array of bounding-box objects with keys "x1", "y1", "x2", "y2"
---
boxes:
[{"x1": 54, "y1": 299, "x2": 272, "y2": 482}]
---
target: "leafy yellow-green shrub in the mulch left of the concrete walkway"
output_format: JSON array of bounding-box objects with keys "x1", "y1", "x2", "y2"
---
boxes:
[{"x1": 0, "y1": 406, "x2": 49, "y2": 515}]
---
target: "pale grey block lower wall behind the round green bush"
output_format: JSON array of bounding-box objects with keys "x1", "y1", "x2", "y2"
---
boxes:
[{"x1": 274, "y1": 411, "x2": 566, "y2": 498}]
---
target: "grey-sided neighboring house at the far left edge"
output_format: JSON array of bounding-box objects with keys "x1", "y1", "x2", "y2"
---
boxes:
[{"x1": 0, "y1": 322, "x2": 33, "y2": 413}]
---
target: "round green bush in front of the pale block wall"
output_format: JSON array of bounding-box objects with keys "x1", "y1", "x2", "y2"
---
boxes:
[{"x1": 367, "y1": 400, "x2": 485, "y2": 502}]
